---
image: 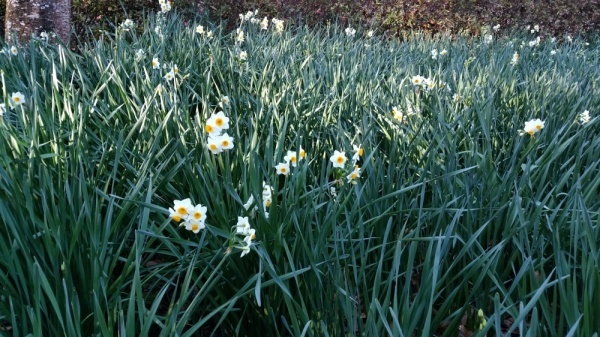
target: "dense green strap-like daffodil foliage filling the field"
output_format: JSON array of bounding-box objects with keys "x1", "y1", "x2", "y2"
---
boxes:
[{"x1": 0, "y1": 8, "x2": 600, "y2": 336}]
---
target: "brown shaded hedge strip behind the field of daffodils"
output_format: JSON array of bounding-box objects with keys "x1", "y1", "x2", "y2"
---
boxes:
[{"x1": 0, "y1": 0, "x2": 600, "y2": 40}]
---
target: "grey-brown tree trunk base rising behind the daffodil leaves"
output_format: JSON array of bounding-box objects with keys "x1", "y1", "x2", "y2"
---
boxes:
[{"x1": 5, "y1": 0, "x2": 71, "y2": 44}]
